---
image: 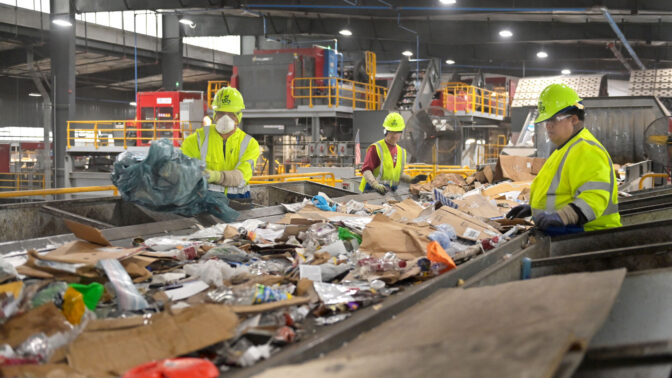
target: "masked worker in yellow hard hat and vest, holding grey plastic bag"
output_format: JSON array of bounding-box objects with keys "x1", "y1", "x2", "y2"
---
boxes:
[{"x1": 182, "y1": 87, "x2": 259, "y2": 198}]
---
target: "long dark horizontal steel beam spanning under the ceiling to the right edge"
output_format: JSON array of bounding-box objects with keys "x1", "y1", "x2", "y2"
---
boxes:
[{"x1": 184, "y1": 12, "x2": 672, "y2": 46}]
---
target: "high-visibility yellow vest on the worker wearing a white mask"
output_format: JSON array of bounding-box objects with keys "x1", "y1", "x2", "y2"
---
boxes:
[{"x1": 182, "y1": 126, "x2": 259, "y2": 195}]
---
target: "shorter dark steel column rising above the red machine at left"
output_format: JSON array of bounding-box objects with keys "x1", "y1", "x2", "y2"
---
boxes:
[{"x1": 161, "y1": 14, "x2": 182, "y2": 91}]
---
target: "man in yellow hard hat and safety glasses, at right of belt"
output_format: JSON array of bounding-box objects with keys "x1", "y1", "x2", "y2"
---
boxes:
[{"x1": 507, "y1": 84, "x2": 621, "y2": 235}]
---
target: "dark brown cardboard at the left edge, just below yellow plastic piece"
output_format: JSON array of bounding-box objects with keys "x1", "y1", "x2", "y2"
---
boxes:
[{"x1": 0, "y1": 302, "x2": 71, "y2": 348}]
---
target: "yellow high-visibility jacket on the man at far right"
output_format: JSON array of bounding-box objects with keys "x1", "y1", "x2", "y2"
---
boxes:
[{"x1": 530, "y1": 128, "x2": 621, "y2": 231}]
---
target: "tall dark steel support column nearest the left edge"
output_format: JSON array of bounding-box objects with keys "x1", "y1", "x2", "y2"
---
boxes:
[{"x1": 49, "y1": 0, "x2": 76, "y2": 188}]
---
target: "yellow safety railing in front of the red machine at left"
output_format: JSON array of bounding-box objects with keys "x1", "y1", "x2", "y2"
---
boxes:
[{"x1": 67, "y1": 120, "x2": 201, "y2": 149}]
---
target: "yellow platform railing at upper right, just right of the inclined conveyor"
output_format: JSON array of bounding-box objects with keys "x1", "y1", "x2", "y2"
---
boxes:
[{"x1": 443, "y1": 83, "x2": 509, "y2": 117}]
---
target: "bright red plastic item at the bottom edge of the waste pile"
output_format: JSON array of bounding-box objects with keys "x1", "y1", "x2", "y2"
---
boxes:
[{"x1": 123, "y1": 358, "x2": 219, "y2": 378}]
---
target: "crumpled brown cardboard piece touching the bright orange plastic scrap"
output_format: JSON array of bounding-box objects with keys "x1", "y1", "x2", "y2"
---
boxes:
[{"x1": 359, "y1": 214, "x2": 432, "y2": 260}]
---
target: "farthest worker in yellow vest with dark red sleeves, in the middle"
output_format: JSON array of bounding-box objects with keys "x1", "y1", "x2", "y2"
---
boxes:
[{"x1": 359, "y1": 113, "x2": 427, "y2": 194}]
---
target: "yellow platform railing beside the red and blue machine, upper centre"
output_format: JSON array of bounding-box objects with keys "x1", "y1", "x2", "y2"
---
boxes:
[{"x1": 292, "y1": 77, "x2": 387, "y2": 110}]
